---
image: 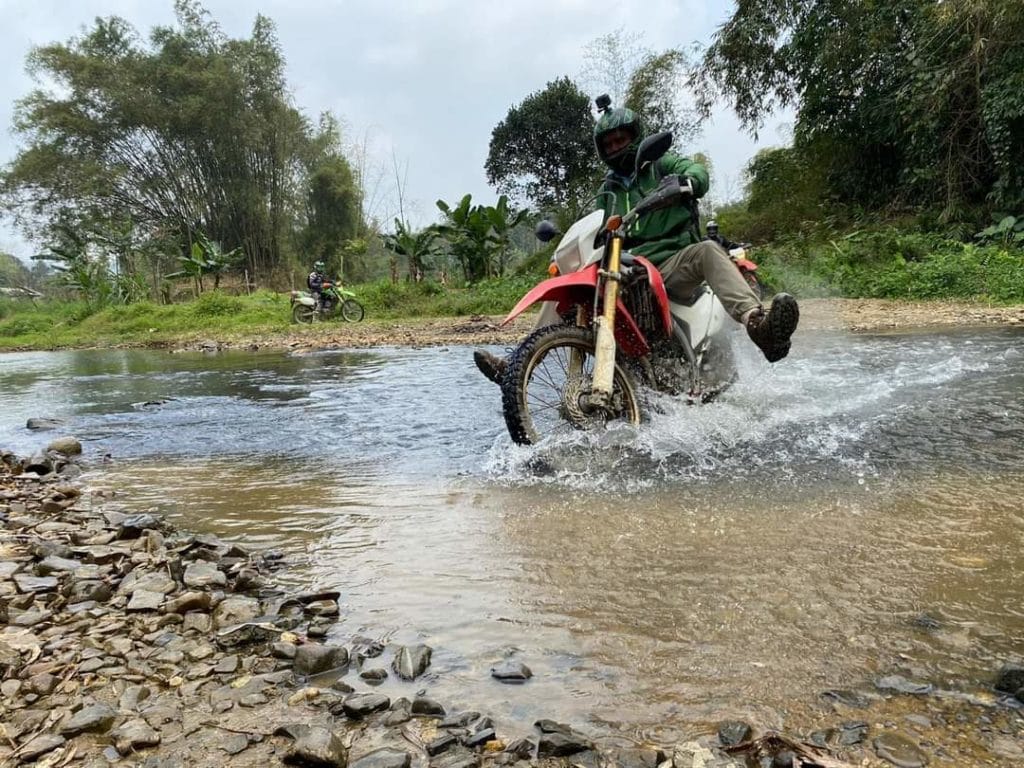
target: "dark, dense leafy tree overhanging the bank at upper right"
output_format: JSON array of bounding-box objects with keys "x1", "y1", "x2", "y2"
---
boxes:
[{"x1": 696, "y1": 0, "x2": 1024, "y2": 219}]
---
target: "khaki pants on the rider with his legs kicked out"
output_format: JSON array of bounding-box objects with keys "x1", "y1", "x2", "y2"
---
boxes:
[{"x1": 657, "y1": 240, "x2": 761, "y2": 322}]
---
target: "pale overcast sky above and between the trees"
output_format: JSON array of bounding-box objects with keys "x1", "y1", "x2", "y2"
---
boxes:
[{"x1": 0, "y1": 0, "x2": 784, "y2": 258}]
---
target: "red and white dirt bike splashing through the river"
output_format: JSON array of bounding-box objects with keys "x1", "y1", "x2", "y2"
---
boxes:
[{"x1": 493, "y1": 133, "x2": 735, "y2": 444}]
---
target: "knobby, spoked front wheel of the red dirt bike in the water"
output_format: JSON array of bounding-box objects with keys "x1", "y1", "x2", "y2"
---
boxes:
[{"x1": 502, "y1": 326, "x2": 640, "y2": 445}]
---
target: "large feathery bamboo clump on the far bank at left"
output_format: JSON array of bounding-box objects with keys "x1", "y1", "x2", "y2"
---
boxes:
[{"x1": 0, "y1": 0, "x2": 362, "y2": 286}]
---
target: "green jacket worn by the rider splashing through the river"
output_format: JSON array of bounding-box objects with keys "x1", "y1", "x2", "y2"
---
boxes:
[{"x1": 598, "y1": 152, "x2": 708, "y2": 264}]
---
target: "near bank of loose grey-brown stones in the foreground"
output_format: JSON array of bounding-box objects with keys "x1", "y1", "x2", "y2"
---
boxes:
[{"x1": 0, "y1": 438, "x2": 1024, "y2": 768}]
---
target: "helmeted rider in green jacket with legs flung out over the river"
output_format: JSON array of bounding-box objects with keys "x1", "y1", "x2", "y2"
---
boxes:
[{"x1": 473, "y1": 99, "x2": 800, "y2": 384}]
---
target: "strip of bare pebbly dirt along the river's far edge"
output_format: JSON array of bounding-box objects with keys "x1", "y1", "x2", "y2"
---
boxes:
[{"x1": 214, "y1": 299, "x2": 1024, "y2": 356}]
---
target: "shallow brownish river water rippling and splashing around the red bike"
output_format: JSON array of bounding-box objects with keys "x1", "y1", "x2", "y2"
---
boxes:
[{"x1": 0, "y1": 331, "x2": 1024, "y2": 753}]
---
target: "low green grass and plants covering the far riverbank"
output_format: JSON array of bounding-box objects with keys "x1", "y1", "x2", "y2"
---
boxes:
[{"x1": 0, "y1": 233, "x2": 1024, "y2": 350}]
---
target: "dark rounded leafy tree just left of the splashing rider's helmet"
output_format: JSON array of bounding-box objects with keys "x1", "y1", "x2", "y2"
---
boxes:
[{"x1": 484, "y1": 78, "x2": 598, "y2": 217}]
